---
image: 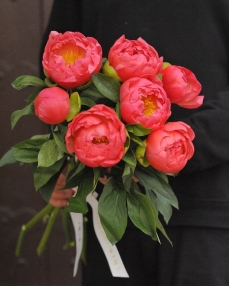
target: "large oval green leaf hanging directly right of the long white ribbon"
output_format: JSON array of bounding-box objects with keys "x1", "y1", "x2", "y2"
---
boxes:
[{"x1": 98, "y1": 178, "x2": 127, "y2": 244}]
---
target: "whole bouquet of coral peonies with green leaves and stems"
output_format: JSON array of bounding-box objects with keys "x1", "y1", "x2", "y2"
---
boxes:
[{"x1": 0, "y1": 31, "x2": 203, "y2": 272}]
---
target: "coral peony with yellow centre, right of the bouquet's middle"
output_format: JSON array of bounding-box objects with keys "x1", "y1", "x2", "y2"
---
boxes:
[{"x1": 120, "y1": 77, "x2": 171, "y2": 130}]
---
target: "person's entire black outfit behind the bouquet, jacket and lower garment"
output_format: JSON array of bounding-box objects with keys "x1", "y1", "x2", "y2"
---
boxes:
[{"x1": 44, "y1": 0, "x2": 229, "y2": 286}]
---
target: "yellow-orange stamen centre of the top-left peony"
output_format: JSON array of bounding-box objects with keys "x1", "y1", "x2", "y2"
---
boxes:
[{"x1": 59, "y1": 44, "x2": 86, "y2": 66}]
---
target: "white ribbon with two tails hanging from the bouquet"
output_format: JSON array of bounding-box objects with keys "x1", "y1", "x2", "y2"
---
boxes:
[{"x1": 71, "y1": 192, "x2": 129, "y2": 278}]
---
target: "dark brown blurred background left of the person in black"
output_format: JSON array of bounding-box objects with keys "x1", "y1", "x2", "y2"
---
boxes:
[{"x1": 0, "y1": 0, "x2": 81, "y2": 286}]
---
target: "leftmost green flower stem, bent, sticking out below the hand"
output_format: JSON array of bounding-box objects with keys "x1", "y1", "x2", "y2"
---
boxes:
[{"x1": 15, "y1": 204, "x2": 54, "y2": 257}]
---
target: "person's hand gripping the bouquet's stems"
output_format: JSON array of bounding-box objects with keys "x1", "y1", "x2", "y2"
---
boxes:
[{"x1": 49, "y1": 174, "x2": 74, "y2": 208}]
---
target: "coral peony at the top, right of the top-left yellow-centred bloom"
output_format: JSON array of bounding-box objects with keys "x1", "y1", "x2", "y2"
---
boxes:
[{"x1": 108, "y1": 35, "x2": 163, "y2": 81}]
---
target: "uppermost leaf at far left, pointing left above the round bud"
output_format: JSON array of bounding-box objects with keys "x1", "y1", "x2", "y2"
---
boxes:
[{"x1": 12, "y1": 75, "x2": 46, "y2": 90}]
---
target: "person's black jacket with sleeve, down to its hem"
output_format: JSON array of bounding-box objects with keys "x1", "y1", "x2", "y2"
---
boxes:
[{"x1": 41, "y1": 0, "x2": 229, "y2": 227}]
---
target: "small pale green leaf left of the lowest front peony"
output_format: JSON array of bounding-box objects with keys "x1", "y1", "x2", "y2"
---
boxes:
[{"x1": 38, "y1": 139, "x2": 64, "y2": 167}]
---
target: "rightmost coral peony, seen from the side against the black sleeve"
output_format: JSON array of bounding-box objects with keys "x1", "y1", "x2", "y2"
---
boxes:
[{"x1": 162, "y1": 65, "x2": 204, "y2": 108}]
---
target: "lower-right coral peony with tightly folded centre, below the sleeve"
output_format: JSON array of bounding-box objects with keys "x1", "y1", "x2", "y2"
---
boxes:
[{"x1": 146, "y1": 121, "x2": 195, "y2": 174}]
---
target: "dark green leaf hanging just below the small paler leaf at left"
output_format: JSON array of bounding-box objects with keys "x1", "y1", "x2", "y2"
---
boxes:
[{"x1": 33, "y1": 157, "x2": 66, "y2": 190}]
